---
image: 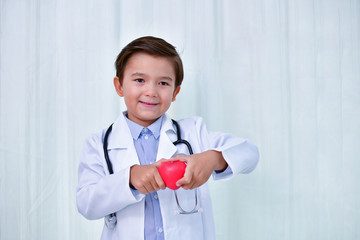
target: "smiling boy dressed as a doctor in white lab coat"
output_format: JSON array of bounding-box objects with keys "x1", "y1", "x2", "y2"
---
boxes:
[{"x1": 77, "y1": 37, "x2": 259, "y2": 240}]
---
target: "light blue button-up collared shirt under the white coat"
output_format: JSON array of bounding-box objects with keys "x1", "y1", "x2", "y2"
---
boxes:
[{"x1": 125, "y1": 116, "x2": 164, "y2": 240}]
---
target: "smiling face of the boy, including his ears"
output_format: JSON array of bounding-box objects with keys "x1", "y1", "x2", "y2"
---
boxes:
[{"x1": 114, "y1": 52, "x2": 180, "y2": 127}]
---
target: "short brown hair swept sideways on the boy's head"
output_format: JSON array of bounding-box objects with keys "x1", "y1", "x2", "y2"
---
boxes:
[{"x1": 115, "y1": 36, "x2": 184, "y2": 88}]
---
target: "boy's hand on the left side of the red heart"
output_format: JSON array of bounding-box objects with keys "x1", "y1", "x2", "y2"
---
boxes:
[{"x1": 130, "y1": 162, "x2": 166, "y2": 194}]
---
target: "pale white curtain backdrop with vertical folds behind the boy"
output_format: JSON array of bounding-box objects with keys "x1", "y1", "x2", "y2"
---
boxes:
[{"x1": 0, "y1": 0, "x2": 360, "y2": 240}]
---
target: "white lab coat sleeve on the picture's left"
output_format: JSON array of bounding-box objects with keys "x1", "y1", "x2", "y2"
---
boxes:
[{"x1": 76, "y1": 135, "x2": 144, "y2": 220}]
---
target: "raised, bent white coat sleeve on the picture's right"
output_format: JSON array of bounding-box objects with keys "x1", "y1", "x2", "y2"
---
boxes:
[{"x1": 196, "y1": 118, "x2": 259, "y2": 180}]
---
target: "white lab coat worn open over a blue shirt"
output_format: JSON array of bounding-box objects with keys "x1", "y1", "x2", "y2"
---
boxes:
[{"x1": 76, "y1": 114, "x2": 259, "y2": 240}]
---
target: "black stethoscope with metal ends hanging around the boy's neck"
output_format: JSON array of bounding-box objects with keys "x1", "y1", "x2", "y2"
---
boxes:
[{"x1": 103, "y1": 119, "x2": 202, "y2": 228}]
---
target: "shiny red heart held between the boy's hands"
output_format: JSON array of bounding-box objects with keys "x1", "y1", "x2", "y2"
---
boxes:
[{"x1": 158, "y1": 161, "x2": 186, "y2": 190}]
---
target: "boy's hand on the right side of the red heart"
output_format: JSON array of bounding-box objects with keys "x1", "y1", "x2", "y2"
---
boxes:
[{"x1": 170, "y1": 150, "x2": 227, "y2": 189}]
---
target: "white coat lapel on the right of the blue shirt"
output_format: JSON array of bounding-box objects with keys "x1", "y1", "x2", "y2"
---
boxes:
[{"x1": 156, "y1": 115, "x2": 177, "y2": 160}]
